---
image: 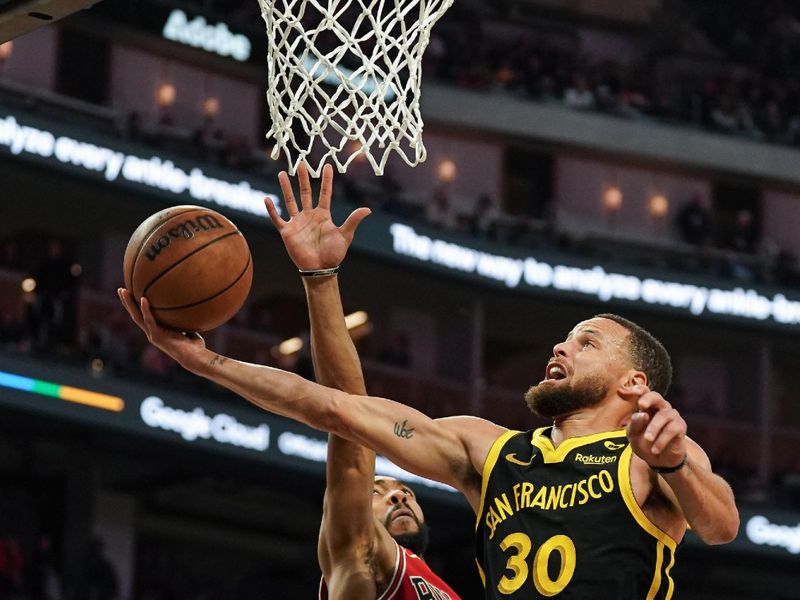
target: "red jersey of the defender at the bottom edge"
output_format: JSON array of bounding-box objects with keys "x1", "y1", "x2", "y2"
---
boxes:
[{"x1": 319, "y1": 542, "x2": 461, "y2": 600}]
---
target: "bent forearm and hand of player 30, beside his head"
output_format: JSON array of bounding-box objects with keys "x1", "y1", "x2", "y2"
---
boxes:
[{"x1": 628, "y1": 390, "x2": 739, "y2": 544}]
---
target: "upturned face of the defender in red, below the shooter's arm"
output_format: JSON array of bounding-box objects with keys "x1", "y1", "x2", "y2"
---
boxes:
[{"x1": 372, "y1": 476, "x2": 428, "y2": 556}]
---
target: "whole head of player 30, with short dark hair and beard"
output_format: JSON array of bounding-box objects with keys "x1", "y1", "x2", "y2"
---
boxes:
[{"x1": 525, "y1": 313, "x2": 672, "y2": 418}]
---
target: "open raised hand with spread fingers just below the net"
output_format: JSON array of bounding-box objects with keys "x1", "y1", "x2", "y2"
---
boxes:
[{"x1": 264, "y1": 163, "x2": 371, "y2": 270}]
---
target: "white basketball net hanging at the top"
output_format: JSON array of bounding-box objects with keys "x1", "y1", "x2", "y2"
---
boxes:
[{"x1": 258, "y1": 0, "x2": 453, "y2": 177}]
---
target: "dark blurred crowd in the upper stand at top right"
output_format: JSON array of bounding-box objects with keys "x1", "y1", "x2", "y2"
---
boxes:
[{"x1": 423, "y1": 0, "x2": 800, "y2": 145}]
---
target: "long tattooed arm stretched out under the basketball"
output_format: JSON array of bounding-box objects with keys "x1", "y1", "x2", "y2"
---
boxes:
[{"x1": 119, "y1": 289, "x2": 505, "y2": 510}]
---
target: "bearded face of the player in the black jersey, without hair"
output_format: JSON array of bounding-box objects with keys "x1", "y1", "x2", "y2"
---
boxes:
[{"x1": 525, "y1": 319, "x2": 630, "y2": 418}]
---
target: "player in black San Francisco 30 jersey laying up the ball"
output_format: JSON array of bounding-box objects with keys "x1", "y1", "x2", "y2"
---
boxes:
[{"x1": 120, "y1": 163, "x2": 739, "y2": 600}]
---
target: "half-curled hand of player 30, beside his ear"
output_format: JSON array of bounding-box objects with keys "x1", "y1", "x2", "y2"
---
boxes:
[{"x1": 628, "y1": 386, "x2": 686, "y2": 468}]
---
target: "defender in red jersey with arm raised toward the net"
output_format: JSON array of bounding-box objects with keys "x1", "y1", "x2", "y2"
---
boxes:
[{"x1": 273, "y1": 167, "x2": 458, "y2": 600}]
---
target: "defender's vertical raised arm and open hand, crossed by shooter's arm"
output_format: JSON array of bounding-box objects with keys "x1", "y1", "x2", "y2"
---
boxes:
[{"x1": 265, "y1": 164, "x2": 388, "y2": 600}]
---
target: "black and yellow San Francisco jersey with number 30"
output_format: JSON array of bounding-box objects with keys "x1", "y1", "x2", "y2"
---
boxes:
[{"x1": 476, "y1": 427, "x2": 676, "y2": 600}]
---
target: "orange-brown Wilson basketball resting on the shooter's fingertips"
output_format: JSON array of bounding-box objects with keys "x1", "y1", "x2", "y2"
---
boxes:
[{"x1": 123, "y1": 206, "x2": 253, "y2": 331}]
